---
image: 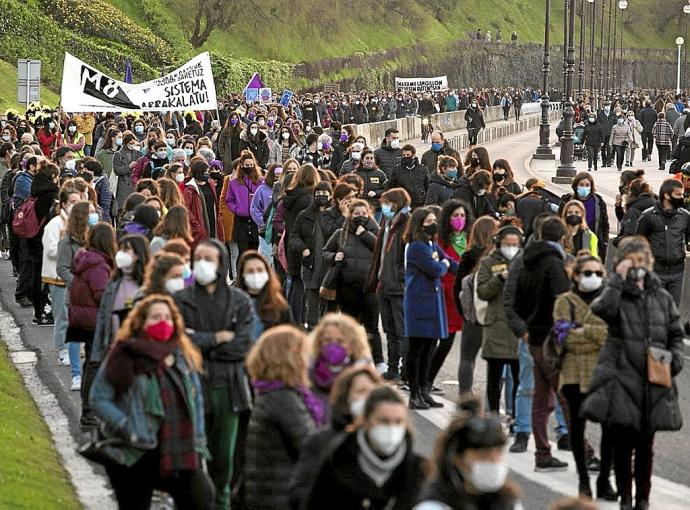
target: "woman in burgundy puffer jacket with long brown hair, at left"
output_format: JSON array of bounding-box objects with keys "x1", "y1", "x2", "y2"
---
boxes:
[{"x1": 66, "y1": 223, "x2": 115, "y2": 423}]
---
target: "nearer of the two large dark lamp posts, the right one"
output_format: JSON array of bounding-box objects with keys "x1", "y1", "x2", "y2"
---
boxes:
[{"x1": 551, "y1": 0, "x2": 575, "y2": 184}]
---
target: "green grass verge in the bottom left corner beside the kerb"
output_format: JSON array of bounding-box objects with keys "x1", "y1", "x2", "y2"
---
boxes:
[{"x1": 0, "y1": 343, "x2": 80, "y2": 510}]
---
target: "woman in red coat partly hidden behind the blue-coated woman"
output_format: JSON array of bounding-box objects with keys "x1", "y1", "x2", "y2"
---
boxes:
[{"x1": 428, "y1": 199, "x2": 472, "y2": 390}]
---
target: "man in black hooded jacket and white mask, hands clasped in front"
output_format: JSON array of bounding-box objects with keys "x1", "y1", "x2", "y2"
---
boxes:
[{"x1": 173, "y1": 239, "x2": 257, "y2": 508}]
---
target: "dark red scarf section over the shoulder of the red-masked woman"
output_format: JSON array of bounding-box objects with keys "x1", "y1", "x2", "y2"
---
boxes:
[{"x1": 105, "y1": 338, "x2": 179, "y2": 394}]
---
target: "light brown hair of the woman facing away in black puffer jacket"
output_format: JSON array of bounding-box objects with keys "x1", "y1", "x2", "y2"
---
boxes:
[{"x1": 246, "y1": 324, "x2": 309, "y2": 388}]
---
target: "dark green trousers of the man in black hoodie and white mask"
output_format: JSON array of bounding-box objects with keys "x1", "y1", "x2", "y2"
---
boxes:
[{"x1": 206, "y1": 387, "x2": 239, "y2": 510}]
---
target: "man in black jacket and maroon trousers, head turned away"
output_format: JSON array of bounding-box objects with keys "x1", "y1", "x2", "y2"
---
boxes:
[{"x1": 507, "y1": 218, "x2": 570, "y2": 471}]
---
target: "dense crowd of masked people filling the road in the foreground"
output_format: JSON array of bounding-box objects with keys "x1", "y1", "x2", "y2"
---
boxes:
[{"x1": 0, "y1": 87, "x2": 690, "y2": 510}]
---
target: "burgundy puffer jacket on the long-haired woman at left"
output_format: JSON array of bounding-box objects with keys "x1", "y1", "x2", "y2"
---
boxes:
[{"x1": 68, "y1": 248, "x2": 112, "y2": 331}]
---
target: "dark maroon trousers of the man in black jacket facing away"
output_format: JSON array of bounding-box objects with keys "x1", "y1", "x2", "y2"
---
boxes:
[{"x1": 529, "y1": 344, "x2": 569, "y2": 461}]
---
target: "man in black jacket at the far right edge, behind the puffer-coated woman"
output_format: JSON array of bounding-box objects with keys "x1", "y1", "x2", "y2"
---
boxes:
[{"x1": 637, "y1": 179, "x2": 690, "y2": 306}]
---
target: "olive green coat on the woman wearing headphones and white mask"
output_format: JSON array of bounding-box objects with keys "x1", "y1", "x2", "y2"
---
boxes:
[{"x1": 477, "y1": 249, "x2": 518, "y2": 359}]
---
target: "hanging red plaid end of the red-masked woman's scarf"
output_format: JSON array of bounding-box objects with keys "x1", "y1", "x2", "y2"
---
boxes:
[{"x1": 155, "y1": 366, "x2": 199, "y2": 478}]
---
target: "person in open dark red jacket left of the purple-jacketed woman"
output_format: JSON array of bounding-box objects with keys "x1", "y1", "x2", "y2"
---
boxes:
[{"x1": 182, "y1": 158, "x2": 225, "y2": 250}]
